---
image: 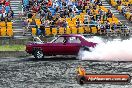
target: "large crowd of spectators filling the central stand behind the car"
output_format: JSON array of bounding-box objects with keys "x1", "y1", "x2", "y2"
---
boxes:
[{"x1": 23, "y1": 0, "x2": 128, "y2": 35}]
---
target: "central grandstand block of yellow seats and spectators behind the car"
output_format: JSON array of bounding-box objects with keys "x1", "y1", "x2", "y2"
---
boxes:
[{"x1": 21, "y1": 0, "x2": 130, "y2": 35}]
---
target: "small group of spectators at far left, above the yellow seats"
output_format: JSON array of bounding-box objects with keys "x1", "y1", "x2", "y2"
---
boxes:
[{"x1": 0, "y1": 0, "x2": 14, "y2": 22}]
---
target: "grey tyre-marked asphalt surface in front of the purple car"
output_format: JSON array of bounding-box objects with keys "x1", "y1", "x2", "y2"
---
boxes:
[{"x1": 0, "y1": 56, "x2": 132, "y2": 88}]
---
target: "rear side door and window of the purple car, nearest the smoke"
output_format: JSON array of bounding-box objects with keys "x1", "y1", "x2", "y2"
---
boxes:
[{"x1": 65, "y1": 37, "x2": 81, "y2": 55}]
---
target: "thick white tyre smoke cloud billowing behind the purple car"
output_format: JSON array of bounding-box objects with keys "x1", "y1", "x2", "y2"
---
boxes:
[{"x1": 79, "y1": 37, "x2": 132, "y2": 61}]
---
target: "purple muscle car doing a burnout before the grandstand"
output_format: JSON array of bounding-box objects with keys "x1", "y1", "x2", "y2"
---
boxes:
[{"x1": 26, "y1": 34, "x2": 97, "y2": 59}]
